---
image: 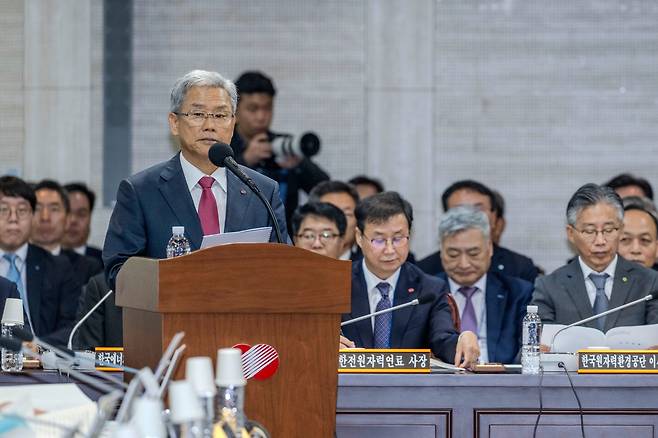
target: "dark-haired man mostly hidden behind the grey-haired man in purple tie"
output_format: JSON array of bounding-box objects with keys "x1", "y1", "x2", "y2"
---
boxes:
[{"x1": 418, "y1": 180, "x2": 539, "y2": 283}]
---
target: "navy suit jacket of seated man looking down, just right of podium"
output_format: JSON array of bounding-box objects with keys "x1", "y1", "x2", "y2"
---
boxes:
[{"x1": 342, "y1": 260, "x2": 459, "y2": 363}]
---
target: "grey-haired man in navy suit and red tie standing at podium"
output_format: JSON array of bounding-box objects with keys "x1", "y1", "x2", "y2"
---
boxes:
[{"x1": 103, "y1": 70, "x2": 288, "y2": 288}]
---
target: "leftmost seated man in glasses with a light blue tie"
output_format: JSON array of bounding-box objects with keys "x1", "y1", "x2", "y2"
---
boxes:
[{"x1": 0, "y1": 176, "x2": 80, "y2": 345}]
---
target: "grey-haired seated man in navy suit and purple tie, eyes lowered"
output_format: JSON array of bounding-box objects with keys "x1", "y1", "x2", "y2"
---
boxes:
[{"x1": 439, "y1": 206, "x2": 533, "y2": 363}]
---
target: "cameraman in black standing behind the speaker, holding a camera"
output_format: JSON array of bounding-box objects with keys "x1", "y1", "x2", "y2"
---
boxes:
[{"x1": 231, "y1": 71, "x2": 329, "y2": 226}]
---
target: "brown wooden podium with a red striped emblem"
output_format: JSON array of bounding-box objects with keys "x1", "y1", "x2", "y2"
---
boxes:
[{"x1": 116, "y1": 243, "x2": 351, "y2": 437}]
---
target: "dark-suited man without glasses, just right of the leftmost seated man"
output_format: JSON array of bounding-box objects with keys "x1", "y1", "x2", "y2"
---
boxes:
[{"x1": 30, "y1": 180, "x2": 103, "y2": 287}]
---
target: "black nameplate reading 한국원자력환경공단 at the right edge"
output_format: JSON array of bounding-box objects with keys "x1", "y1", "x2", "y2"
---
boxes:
[{"x1": 578, "y1": 350, "x2": 658, "y2": 374}]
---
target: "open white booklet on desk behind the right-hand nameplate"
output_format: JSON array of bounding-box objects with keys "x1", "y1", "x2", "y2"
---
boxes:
[{"x1": 541, "y1": 324, "x2": 658, "y2": 353}]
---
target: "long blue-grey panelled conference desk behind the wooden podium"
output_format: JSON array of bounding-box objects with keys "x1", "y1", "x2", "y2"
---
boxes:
[{"x1": 0, "y1": 371, "x2": 658, "y2": 438}]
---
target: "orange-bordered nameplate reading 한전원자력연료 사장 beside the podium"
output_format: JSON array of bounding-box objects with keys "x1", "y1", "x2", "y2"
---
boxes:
[{"x1": 338, "y1": 348, "x2": 430, "y2": 373}]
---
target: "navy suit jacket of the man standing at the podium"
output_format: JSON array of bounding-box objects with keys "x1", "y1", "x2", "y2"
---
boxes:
[{"x1": 103, "y1": 153, "x2": 288, "y2": 288}]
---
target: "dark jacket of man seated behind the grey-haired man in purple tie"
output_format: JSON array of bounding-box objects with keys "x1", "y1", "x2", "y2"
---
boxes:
[{"x1": 416, "y1": 245, "x2": 539, "y2": 283}]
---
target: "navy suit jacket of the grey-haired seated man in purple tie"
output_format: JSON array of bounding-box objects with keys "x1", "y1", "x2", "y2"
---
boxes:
[{"x1": 439, "y1": 272, "x2": 534, "y2": 363}]
